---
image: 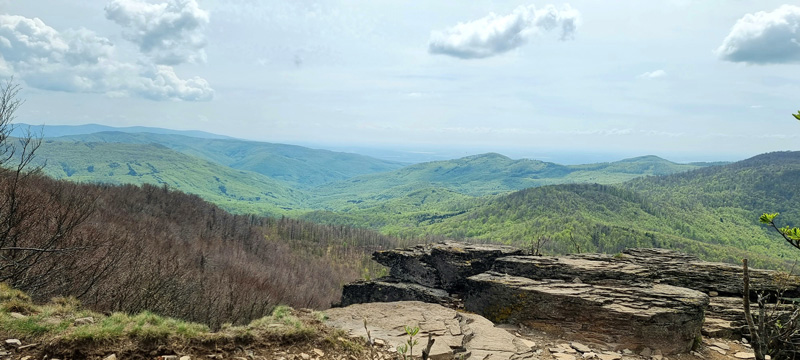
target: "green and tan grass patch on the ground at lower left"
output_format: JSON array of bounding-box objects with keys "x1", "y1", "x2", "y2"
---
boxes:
[{"x1": 0, "y1": 284, "x2": 332, "y2": 352}]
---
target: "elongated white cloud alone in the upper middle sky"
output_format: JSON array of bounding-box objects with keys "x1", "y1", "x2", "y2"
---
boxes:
[{"x1": 428, "y1": 5, "x2": 580, "y2": 59}]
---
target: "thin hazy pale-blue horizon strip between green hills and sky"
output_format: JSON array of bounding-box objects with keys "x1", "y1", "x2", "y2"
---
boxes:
[{"x1": 15, "y1": 123, "x2": 768, "y2": 165}]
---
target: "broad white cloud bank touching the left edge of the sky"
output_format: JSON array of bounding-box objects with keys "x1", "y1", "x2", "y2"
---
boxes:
[{"x1": 0, "y1": 15, "x2": 214, "y2": 101}]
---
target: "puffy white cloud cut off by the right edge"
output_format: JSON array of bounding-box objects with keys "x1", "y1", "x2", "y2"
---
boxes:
[{"x1": 716, "y1": 5, "x2": 800, "y2": 65}]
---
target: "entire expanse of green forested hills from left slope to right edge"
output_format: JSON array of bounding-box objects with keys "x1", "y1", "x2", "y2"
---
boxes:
[{"x1": 21, "y1": 123, "x2": 800, "y2": 267}]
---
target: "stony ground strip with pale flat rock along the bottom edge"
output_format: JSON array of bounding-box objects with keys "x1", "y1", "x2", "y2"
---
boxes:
[{"x1": 0, "y1": 302, "x2": 764, "y2": 360}]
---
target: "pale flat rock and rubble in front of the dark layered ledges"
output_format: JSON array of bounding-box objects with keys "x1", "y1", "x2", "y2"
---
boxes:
[{"x1": 326, "y1": 301, "x2": 754, "y2": 360}]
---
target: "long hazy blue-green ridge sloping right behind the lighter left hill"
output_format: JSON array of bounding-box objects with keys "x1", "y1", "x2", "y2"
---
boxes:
[{"x1": 56, "y1": 132, "x2": 405, "y2": 188}]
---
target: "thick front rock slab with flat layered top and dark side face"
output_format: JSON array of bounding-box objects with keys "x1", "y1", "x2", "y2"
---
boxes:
[{"x1": 464, "y1": 272, "x2": 709, "y2": 354}]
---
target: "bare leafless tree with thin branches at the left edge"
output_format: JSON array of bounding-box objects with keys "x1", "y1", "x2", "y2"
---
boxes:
[{"x1": 0, "y1": 79, "x2": 96, "y2": 292}]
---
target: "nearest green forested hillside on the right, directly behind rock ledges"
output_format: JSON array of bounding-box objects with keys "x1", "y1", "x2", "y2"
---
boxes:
[{"x1": 306, "y1": 152, "x2": 800, "y2": 267}]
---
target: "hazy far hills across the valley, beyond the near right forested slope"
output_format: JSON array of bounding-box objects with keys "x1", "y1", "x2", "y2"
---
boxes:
[{"x1": 29, "y1": 126, "x2": 720, "y2": 215}]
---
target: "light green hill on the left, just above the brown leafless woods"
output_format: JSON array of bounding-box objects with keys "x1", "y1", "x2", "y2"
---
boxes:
[{"x1": 36, "y1": 140, "x2": 307, "y2": 214}]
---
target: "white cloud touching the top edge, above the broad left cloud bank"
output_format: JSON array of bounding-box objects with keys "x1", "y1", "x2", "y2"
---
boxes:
[{"x1": 105, "y1": 0, "x2": 209, "y2": 65}]
